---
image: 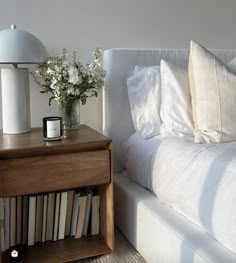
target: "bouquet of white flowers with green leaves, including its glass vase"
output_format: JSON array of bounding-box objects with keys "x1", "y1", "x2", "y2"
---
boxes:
[{"x1": 31, "y1": 48, "x2": 105, "y2": 129}]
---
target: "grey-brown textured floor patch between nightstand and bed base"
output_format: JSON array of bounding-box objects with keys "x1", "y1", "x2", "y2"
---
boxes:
[{"x1": 76, "y1": 229, "x2": 146, "y2": 263}]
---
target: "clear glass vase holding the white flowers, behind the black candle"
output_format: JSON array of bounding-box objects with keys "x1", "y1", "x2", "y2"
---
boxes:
[{"x1": 60, "y1": 100, "x2": 80, "y2": 130}]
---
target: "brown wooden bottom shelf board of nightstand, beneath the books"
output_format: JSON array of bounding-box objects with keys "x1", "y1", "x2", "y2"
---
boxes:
[{"x1": 3, "y1": 236, "x2": 112, "y2": 263}]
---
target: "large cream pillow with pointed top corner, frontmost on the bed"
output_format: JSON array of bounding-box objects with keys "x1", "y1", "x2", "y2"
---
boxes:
[{"x1": 189, "y1": 41, "x2": 236, "y2": 143}]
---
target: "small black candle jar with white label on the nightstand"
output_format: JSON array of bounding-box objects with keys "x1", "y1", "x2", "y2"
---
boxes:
[{"x1": 43, "y1": 116, "x2": 63, "y2": 141}]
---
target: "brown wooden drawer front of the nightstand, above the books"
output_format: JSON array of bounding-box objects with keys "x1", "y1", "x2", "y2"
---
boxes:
[{"x1": 0, "y1": 150, "x2": 110, "y2": 197}]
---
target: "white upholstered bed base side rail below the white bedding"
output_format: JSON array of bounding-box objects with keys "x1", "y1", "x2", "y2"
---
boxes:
[{"x1": 114, "y1": 174, "x2": 236, "y2": 263}]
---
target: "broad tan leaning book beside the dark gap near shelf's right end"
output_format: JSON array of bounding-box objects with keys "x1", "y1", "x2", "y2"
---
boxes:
[{"x1": 75, "y1": 194, "x2": 87, "y2": 238}]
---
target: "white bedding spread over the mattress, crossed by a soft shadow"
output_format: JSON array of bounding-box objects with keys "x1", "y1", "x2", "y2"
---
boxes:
[{"x1": 123, "y1": 134, "x2": 236, "y2": 253}]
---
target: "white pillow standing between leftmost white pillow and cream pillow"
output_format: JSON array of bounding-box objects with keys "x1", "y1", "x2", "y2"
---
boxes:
[{"x1": 160, "y1": 60, "x2": 193, "y2": 138}]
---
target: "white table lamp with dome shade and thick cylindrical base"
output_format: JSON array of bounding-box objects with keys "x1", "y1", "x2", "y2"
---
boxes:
[{"x1": 0, "y1": 25, "x2": 47, "y2": 134}]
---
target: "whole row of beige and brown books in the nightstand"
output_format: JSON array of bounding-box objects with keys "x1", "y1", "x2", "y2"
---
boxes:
[{"x1": 0, "y1": 189, "x2": 100, "y2": 251}]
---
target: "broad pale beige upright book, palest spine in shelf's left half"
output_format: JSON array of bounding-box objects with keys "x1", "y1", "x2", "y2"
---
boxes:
[{"x1": 28, "y1": 196, "x2": 36, "y2": 246}]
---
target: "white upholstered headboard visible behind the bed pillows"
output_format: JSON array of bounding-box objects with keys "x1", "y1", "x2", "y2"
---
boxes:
[{"x1": 103, "y1": 49, "x2": 236, "y2": 172}]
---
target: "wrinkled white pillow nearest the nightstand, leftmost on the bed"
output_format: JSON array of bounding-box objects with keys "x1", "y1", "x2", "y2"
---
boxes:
[{"x1": 127, "y1": 66, "x2": 161, "y2": 139}]
